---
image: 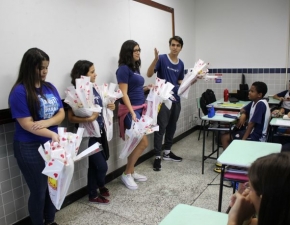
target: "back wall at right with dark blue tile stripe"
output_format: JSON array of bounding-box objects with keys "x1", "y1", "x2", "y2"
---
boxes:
[{"x1": 194, "y1": 0, "x2": 290, "y2": 112}]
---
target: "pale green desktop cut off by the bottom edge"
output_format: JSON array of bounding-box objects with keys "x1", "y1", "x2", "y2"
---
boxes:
[{"x1": 159, "y1": 204, "x2": 228, "y2": 225}]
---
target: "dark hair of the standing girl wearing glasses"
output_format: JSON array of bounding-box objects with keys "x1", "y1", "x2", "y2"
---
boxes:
[{"x1": 118, "y1": 40, "x2": 141, "y2": 72}]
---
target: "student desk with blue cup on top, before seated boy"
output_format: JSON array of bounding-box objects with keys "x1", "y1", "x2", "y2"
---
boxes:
[{"x1": 201, "y1": 115, "x2": 236, "y2": 174}]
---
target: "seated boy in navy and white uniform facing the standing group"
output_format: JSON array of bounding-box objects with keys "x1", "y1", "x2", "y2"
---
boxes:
[{"x1": 221, "y1": 81, "x2": 271, "y2": 151}]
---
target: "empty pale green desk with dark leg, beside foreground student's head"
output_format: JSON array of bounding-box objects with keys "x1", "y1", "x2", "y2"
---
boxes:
[{"x1": 217, "y1": 140, "x2": 282, "y2": 212}]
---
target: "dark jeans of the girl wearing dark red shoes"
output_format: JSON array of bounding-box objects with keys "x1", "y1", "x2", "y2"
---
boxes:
[{"x1": 88, "y1": 132, "x2": 108, "y2": 198}]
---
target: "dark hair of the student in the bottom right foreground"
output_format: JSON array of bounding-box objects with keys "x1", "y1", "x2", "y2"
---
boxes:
[{"x1": 248, "y1": 152, "x2": 290, "y2": 225}]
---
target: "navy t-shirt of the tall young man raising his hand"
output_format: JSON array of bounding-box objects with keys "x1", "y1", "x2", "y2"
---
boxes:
[{"x1": 154, "y1": 54, "x2": 184, "y2": 102}]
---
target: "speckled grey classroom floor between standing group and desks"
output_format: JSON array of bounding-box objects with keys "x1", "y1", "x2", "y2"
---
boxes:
[{"x1": 56, "y1": 131, "x2": 232, "y2": 225}]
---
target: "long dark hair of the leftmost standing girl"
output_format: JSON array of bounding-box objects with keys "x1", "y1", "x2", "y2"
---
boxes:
[{"x1": 10, "y1": 48, "x2": 54, "y2": 120}]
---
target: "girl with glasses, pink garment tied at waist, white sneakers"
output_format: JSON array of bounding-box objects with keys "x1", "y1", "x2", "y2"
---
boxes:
[{"x1": 116, "y1": 40, "x2": 148, "y2": 190}]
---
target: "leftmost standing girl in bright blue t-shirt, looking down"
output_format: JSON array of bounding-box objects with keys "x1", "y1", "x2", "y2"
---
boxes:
[{"x1": 9, "y1": 48, "x2": 64, "y2": 225}]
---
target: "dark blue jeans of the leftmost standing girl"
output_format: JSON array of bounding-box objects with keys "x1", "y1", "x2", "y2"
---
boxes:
[{"x1": 13, "y1": 141, "x2": 56, "y2": 225}]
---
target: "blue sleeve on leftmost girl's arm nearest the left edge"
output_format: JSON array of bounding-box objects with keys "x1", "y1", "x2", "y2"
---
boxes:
[{"x1": 9, "y1": 85, "x2": 31, "y2": 119}]
